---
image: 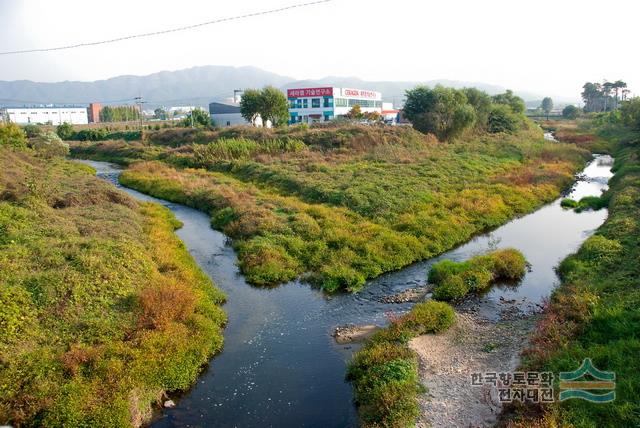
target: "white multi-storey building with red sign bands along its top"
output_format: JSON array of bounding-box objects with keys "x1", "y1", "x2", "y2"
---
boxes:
[{"x1": 287, "y1": 87, "x2": 382, "y2": 123}]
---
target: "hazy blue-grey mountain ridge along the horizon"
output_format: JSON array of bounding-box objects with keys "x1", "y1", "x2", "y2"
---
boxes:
[{"x1": 0, "y1": 65, "x2": 576, "y2": 108}]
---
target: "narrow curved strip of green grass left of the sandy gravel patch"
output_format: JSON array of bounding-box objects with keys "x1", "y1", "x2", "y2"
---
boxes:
[{"x1": 347, "y1": 301, "x2": 455, "y2": 427}]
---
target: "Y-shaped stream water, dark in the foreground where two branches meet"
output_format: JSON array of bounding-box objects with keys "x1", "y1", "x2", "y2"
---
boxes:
[{"x1": 79, "y1": 156, "x2": 611, "y2": 427}]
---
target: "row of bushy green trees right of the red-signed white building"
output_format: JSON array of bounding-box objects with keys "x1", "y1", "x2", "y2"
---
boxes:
[{"x1": 404, "y1": 85, "x2": 525, "y2": 140}]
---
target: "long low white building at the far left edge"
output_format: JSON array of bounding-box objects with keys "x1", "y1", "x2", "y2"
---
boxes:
[{"x1": 0, "y1": 107, "x2": 89, "y2": 125}]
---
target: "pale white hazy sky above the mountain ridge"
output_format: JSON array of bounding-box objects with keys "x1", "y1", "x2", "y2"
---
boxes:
[{"x1": 0, "y1": 0, "x2": 640, "y2": 98}]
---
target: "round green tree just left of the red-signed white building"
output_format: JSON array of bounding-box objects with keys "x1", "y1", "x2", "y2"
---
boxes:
[{"x1": 240, "y1": 86, "x2": 289, "y2": 126}]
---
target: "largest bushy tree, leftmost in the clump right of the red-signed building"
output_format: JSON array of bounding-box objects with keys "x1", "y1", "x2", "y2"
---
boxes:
[{"x1": 404, "y1": 85, "x2": 475, "y2": 140}]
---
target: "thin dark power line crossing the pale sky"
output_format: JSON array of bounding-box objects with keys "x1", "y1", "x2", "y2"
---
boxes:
[{"x1": 0, "y1": 0, "x2": 333, "y2": 55}]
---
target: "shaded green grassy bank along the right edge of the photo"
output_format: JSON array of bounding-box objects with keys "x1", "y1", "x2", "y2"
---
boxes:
[{"x1": 503, "y1": 122, "x2": 640, "y2": 427}]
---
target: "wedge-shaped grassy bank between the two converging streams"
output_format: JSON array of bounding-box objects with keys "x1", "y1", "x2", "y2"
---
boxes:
[{"x1": 72, "y1": 126, "x2": 588, "y2": 291}]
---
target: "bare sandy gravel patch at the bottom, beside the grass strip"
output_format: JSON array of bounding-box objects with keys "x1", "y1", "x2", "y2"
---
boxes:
[{"x1": 410, "y1": 311, "x2": 536, "y2": 428}]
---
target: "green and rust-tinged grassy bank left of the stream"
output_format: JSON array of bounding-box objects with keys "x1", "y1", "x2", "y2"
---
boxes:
[{"x1": 0, "y1": 148, "x2": 226, "y2": 427}]
